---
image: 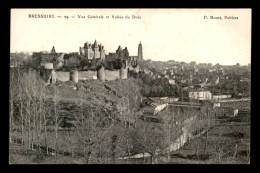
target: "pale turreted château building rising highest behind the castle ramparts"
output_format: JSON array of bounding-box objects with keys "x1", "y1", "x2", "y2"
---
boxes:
[{"x1": 79, "y1": 40, "x2": 105, "y2": 60}]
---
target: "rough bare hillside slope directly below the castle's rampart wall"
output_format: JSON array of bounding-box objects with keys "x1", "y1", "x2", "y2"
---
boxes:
[{"x1": 44, "y1": 78, "x2": 141, "y2": 126}]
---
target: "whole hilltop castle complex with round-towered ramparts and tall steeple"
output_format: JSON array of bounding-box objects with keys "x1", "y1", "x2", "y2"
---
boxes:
[{"x1": 33, "y1": 40, "x2": 143, "y2": 84}]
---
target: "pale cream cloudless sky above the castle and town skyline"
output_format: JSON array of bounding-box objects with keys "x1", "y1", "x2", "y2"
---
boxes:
[{"x1": 10, "y1": 9, "x2": 251, "y2": 65}]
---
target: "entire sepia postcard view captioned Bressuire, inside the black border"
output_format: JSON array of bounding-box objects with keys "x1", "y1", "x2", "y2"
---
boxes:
[{"x1": 8, "y1": 8, "x2": 252, "y2": 165}]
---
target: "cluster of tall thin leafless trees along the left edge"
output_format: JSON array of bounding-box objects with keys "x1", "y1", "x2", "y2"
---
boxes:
[{"x1": 9, "y1": 68, "x2": 59, "y2": 154}]
